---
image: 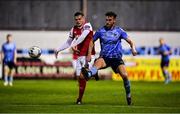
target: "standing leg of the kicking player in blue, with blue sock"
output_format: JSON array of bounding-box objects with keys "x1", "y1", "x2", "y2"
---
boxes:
[{"x1": 118, "y1": 65, "x2": 131, "y2": 105}]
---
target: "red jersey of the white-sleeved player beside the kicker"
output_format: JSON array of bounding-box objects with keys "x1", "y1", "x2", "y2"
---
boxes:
[{"x1": 70, "y1": 23, "x2": 95, "y2": 56}]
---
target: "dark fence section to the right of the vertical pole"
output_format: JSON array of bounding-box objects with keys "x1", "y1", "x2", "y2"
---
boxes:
[{"x1": 88, "y1": 0, "x2": 180, "y2": 31}]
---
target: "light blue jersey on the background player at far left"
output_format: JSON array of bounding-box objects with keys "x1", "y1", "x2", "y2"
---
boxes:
[{"x1": 2, "y1": 42, "x2": 16, "y2": 63}]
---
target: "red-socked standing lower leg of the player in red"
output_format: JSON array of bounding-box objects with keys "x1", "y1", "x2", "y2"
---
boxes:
[{"x1": 76, "y1": 74, "x2": 86, "y2": 104}]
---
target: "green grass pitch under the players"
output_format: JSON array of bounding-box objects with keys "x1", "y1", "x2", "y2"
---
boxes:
[{"x1": 0, "y1": 80, "x2": 180, "y2": 113}]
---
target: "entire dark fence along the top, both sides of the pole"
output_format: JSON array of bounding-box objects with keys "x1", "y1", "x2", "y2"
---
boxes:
[{"x1": 0, "y1": 0, "x2": 180, "y2": 31}]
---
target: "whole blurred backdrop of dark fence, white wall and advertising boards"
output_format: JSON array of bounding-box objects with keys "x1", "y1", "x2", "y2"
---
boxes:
[{"x1": 0, "y1": 0, "x2": 180, "y2": 81}]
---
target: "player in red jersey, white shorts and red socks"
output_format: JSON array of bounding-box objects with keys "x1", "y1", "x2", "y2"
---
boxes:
[{"x1": 55, "y1": 12, "x2": 95, "y2": 104}]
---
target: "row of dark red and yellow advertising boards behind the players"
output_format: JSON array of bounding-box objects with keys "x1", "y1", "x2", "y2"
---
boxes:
[{"x1": 15, "y1": 54, "x2": 180, "y2": 81}]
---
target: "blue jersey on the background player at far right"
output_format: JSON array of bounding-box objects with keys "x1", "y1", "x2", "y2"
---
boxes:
[{"x1": 159, "y1": 44, "x2": 171, "y2": 61}]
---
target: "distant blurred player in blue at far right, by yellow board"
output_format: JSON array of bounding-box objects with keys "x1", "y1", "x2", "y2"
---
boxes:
[{"x1": 159, "y1": 38, "x2": 172, "y2": 84}]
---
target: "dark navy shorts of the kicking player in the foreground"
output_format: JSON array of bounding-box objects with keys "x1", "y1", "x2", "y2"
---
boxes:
[{"x1": 102, "y1": 57, "x2": 124, "y2": 73}]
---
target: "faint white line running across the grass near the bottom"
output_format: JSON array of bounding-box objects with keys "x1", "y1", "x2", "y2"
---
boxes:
[{"x1": 4, "y1": 104, "x2": 180, "y2": 109}]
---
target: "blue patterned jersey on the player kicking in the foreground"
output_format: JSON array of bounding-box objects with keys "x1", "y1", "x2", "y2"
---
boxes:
[{"x1": 93, "y1": 26, "x2": 128, "y2": 58}]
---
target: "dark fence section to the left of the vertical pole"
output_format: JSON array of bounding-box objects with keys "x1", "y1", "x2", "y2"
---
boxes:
[{"x1": 0, "y1": 0, "x2": 80, "y2": 30}]
